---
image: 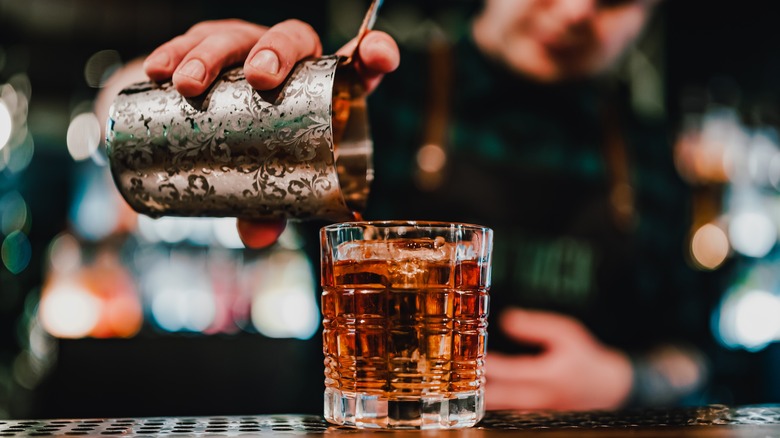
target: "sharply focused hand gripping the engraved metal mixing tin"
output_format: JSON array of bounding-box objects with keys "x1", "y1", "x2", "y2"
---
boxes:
[{"x1": 144, "y1": 19, "x2": 400, "y2": 97}]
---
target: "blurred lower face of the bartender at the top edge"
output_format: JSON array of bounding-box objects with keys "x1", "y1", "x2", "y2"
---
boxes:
[{"x1": 475, "y1": 0, "x2": 656, "y2": 82}]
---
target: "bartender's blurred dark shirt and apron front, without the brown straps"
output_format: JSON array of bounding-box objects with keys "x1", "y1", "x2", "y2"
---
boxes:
[{"x1": 364, "y1": 34, "x2": 708, "y2": 362}]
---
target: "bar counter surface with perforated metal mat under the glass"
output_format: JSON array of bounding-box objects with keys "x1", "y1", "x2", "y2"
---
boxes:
[{"x1": 0, "y1": 405, "x2": 780, "y2": 438}]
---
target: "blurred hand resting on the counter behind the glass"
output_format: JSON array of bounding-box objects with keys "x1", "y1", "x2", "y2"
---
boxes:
[{"x1": 485, "y1": 309, "x2": 633, "y2": 410}]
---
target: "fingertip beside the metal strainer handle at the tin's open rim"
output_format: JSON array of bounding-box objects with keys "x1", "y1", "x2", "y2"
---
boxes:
[{"x1": 337, "y1": 31, "x2": 401, "y2": 92}]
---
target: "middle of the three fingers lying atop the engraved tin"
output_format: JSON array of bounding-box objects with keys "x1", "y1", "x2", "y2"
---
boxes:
[{"x1": 173, "y1": 21, "x2": 265, "y2": 97}]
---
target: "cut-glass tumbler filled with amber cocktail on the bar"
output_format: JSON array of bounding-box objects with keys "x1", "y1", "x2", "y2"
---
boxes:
[{"x1": 321, "y1": 221, "x2": 492, "y2": 429}]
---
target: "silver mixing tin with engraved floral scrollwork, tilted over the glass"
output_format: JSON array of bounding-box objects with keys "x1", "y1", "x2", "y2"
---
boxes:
[{"x1": 106, "y1": 56, "x2": 373, "y2": 221}]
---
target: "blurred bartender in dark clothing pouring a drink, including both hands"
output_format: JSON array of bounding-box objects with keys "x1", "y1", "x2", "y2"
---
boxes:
[{"x1": 117, "y1": 0, "x2": 708, "y2": 410}]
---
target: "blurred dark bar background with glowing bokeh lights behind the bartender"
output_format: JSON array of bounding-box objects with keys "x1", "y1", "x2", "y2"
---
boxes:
[{"x1": 0, "y1": 0, "x2": 780, "y2": 419}]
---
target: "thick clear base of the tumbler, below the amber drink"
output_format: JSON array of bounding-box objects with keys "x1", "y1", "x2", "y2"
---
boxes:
[{"x1": 325, "y1": 388, "x2": 485, "y2": 429}]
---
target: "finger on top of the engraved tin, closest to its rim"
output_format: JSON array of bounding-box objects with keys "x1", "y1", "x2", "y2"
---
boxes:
[{"x1": 244, "y1": 20, "x2": 322, "y2": 90}]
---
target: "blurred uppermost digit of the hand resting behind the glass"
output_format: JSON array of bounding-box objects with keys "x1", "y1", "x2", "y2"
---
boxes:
[{"x1": 499, "y1": 308, "x2": 584, "y2": 348}]
